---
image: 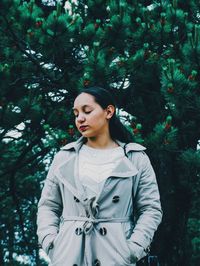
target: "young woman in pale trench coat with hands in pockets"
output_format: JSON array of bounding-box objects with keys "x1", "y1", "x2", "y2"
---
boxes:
[{"x1": 37, "y1": 87, "x2": 162, "y2": 266}]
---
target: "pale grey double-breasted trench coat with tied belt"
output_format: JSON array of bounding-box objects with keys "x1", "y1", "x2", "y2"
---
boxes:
[{"x1": 37, "y1": 137, "x2": 162, "y2": 266}]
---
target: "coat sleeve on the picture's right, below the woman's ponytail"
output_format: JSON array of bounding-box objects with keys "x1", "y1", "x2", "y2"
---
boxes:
[{"x1": 129, "y1": 153, "x2": 162, "y2": 260}]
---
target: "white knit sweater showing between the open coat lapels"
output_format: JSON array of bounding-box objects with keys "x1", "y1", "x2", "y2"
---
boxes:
[{"x1": 79, "y1": 145, "x2": 125, "y2": 196}]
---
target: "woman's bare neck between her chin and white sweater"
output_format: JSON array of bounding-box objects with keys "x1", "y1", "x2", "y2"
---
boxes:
[{"x1": 86, "y1": 136, "x2": 118, "y2": 149}]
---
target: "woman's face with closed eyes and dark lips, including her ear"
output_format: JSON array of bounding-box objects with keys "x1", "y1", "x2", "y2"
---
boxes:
[{"x1": 73, "y1": 93, "x2": 114, "y2": 138}]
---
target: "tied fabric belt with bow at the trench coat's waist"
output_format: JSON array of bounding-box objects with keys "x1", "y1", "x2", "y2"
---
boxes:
[{"x1": 62, "y1": 197, "x2": 131, "y2": 234}]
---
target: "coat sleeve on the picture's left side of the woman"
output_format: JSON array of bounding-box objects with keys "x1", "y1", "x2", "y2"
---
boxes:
[{"x1": 37, "y1": 153, "x2": 62, "y2": 253}]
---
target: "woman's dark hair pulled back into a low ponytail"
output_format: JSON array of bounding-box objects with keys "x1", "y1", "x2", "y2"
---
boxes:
[{"x1": 77, "y1": 87, "x2": 133, "y2": 143}]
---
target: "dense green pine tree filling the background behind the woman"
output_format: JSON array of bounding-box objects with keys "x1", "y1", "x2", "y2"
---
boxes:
[{"x1": 0, "y1": 0, "x2": 200, "y2": 266}]
